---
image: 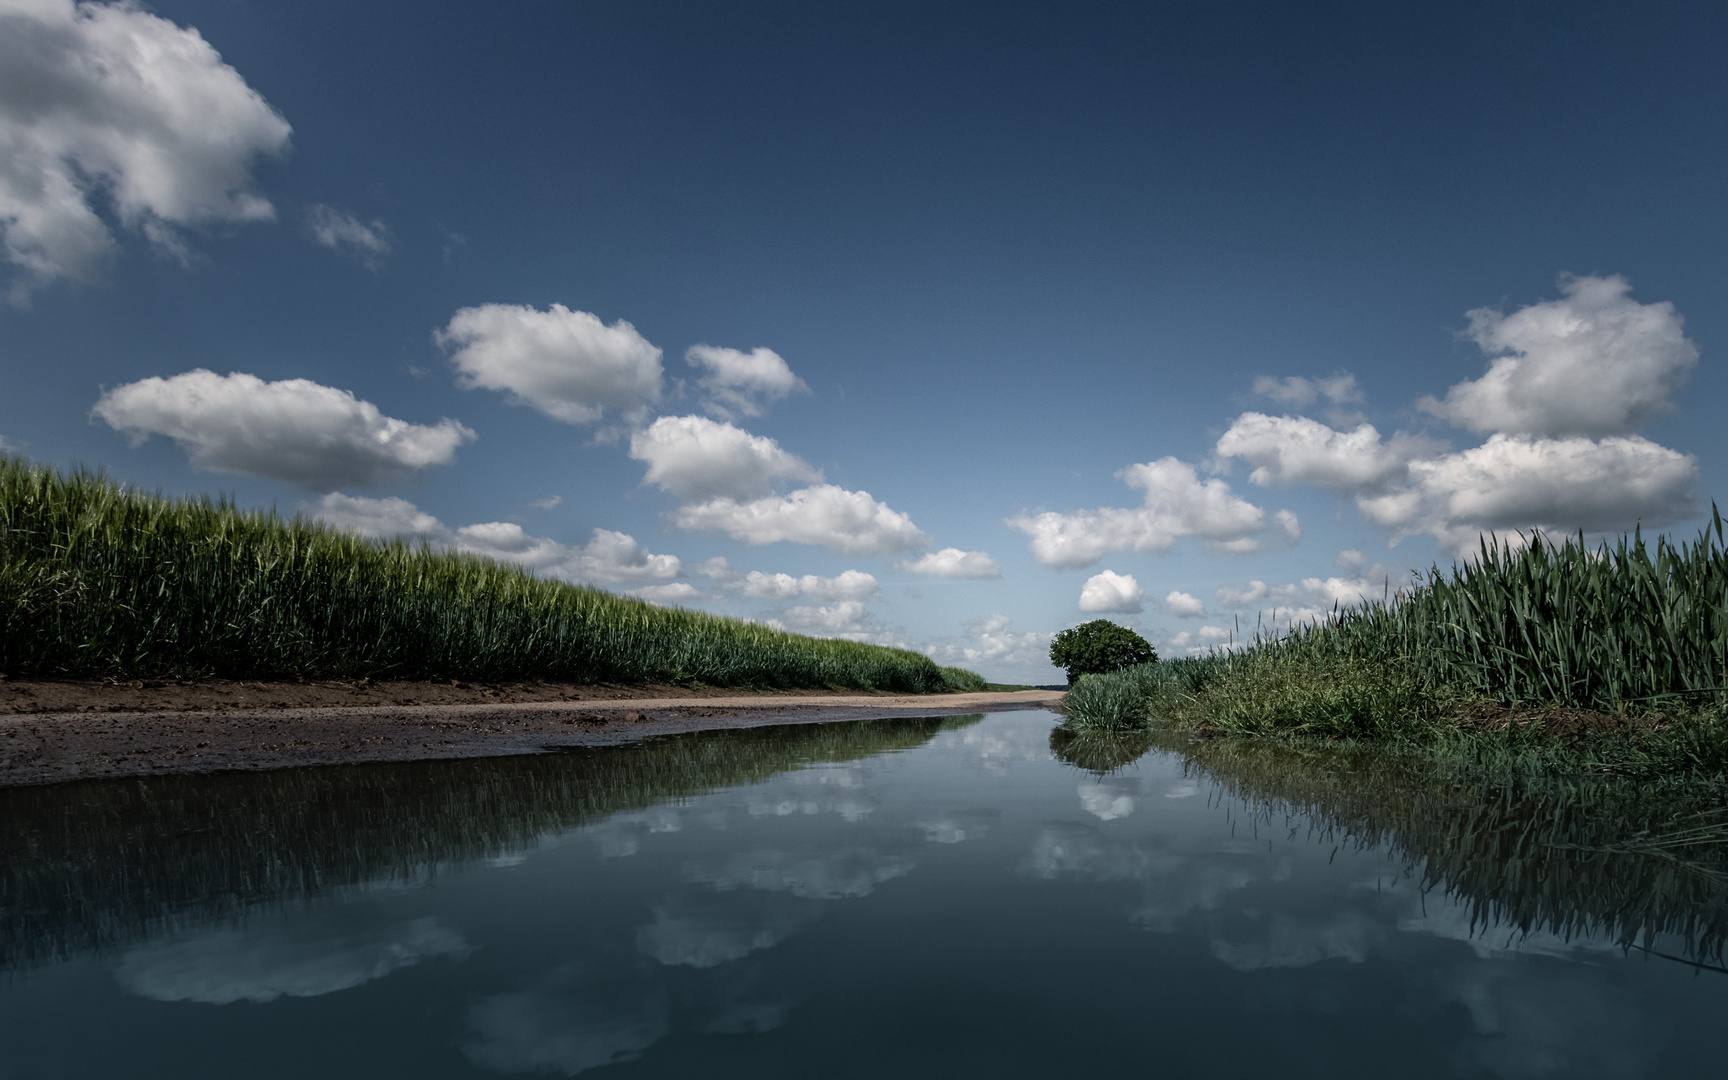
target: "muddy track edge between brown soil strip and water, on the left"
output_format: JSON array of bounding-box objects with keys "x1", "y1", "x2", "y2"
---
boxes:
[{"x1": 0, "y1": 688, "x2": 1063, "y2": 786}]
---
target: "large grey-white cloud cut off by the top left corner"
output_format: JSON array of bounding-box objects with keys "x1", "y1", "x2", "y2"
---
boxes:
[{"x1": 0, "y1": 0, "x2": 290, "y2": 301}]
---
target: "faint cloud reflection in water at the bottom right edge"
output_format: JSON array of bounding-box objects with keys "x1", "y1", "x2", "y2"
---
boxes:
[{"x1": 1446, "y1": 961, "x2": 1671, "y2": 1080}]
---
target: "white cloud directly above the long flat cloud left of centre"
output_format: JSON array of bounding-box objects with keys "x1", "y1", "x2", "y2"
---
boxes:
[{"x1": 631, "y1": 416, "x2": 823, "y2": 501}]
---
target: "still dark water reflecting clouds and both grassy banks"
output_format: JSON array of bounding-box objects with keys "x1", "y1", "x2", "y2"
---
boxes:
[{"x1": 0, "y1": 712, "x2": 1728, "y2": 1080}]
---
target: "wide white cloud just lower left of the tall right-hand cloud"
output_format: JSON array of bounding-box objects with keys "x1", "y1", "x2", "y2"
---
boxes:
[{"x1": 1217, "y1": 413, "x2": 1445, "y2": 492}]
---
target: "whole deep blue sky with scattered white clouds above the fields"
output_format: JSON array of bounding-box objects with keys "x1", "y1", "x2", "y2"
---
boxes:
[{"x1": 0, "y1": 0, "x2": 1728, "y2": 683}]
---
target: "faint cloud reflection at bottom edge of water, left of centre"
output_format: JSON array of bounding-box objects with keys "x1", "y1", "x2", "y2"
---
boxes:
[{"x1": 461, "y1": 968, "x2": 670, "y2": 1077}]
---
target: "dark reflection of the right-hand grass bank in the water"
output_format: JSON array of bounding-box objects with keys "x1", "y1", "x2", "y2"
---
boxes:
[{"x1": 1159, "y1": 734, "x2": 1728, "y2": 964}]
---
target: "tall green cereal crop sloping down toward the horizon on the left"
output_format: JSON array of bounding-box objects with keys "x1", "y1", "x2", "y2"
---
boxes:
[{"x1": 0, "y1": 458, "x2": 982, "y2": 693}]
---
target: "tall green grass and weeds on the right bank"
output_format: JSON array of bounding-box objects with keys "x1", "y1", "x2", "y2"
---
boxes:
[{"x1": 1068, "y1": 511, "x2": 1728, "y2": 738}]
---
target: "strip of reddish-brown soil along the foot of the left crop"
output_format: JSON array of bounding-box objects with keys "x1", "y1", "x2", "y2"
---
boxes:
[{"x1": 0, "y1": 676, "x2": 880, "y2": 715}]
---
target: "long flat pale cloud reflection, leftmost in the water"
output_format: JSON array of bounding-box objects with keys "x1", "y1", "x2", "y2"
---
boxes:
[{"x1": 114, "y1": 918, "x2": 468, "y2": 1006}]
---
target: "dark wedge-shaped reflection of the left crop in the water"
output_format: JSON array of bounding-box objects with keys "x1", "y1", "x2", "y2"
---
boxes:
[{"x1": 0, "y1": 715, "x2": 983, "y2": 966}]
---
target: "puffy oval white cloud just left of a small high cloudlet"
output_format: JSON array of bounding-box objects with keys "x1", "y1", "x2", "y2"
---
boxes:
[{"x1": 432, "y1": 304, "x2": 660, "y2": 423}]
